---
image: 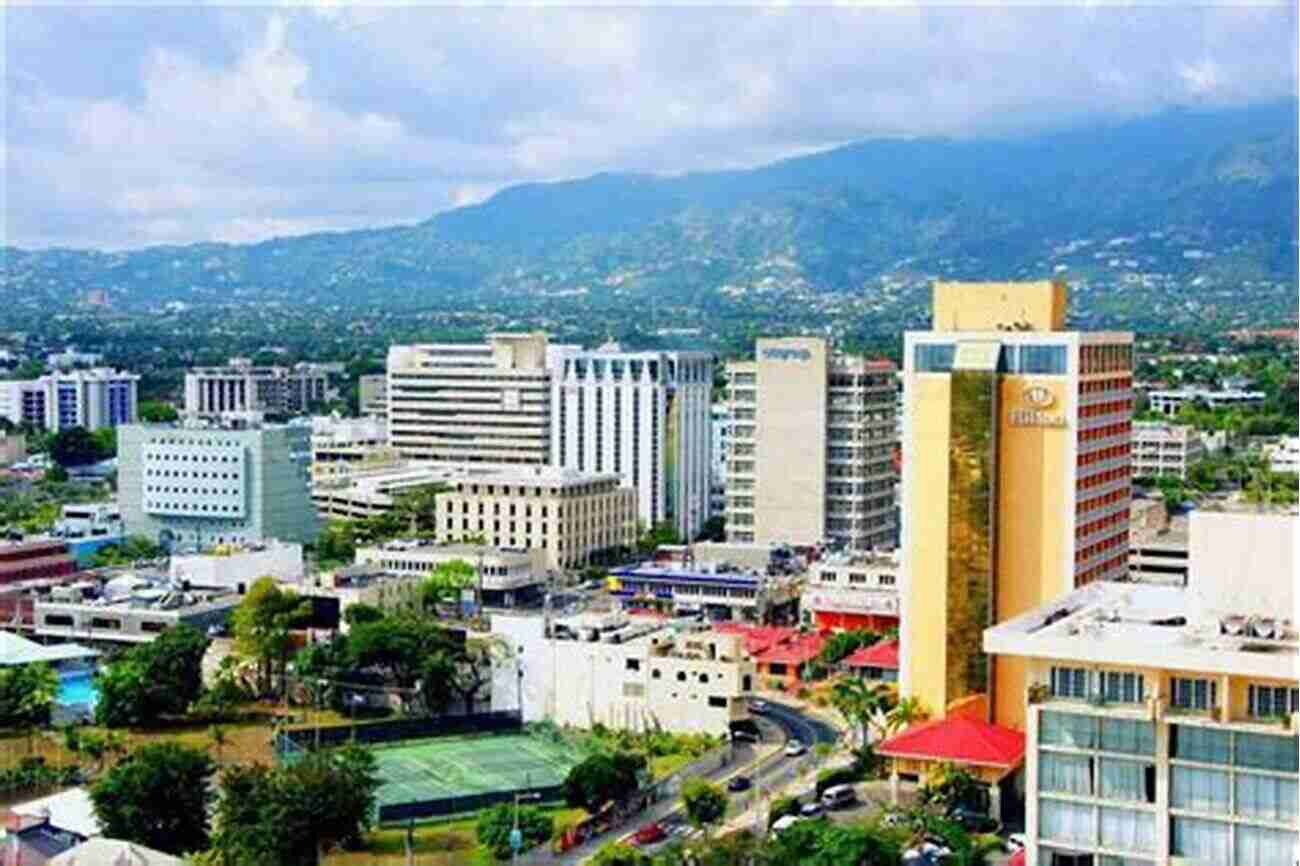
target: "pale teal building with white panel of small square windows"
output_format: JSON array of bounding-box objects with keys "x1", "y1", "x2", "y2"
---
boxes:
[{"x1": 117, "y1": 424, "x2": 320, "y2": 547}]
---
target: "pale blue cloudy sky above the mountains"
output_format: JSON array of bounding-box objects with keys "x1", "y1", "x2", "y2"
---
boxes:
[{"x1": 0, "y1": 3, "x2": 1296, "y2": 248}]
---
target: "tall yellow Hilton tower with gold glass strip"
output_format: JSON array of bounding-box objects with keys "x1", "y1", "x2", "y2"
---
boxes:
[{"x1": 881, "y1": 281, "x2": 1134, "y2": 781}]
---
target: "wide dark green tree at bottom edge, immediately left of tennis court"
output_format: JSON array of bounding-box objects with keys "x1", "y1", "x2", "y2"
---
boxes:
[{"x1": 213, "y1": 745, "x2": 380, "y2": 866}]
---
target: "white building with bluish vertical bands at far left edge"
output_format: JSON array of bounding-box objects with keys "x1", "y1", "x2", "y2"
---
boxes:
[{"x1": 0, "y1": 368, "x2": 140, "y2": 433}]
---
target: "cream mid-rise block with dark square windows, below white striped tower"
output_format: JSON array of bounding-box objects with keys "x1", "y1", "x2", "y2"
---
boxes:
[{"x1": 434, "y1": 467, "x2": 637, "y2": 570}]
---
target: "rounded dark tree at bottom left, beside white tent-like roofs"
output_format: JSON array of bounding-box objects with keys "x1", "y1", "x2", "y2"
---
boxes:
[{"x1": 90, "y1": 742, "x2": 212, "y2": 854}]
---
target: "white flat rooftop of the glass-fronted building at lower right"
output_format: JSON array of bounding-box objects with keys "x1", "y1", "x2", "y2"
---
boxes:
[{"x1": 984, "y1": 583, "x2": 1300, "y2": 679}]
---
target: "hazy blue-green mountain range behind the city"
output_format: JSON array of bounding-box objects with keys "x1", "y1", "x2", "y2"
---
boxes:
[{"x1": 0, "y1": 101, "x2": 1300, "y2": 330}]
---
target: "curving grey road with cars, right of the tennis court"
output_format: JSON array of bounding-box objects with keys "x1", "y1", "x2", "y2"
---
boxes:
[{"x1": 533, "y1": 701, "x2": 839, "y2": 866}]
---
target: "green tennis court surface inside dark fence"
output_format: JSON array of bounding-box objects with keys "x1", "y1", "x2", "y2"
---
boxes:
[{"x1": 374, "y1": 733, "x2": 582, "y2": 806}]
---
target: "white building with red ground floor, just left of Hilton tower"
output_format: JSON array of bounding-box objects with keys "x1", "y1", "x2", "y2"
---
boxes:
[{"x1": 800, "y1": 550, "x2": 901, "y2": 632}]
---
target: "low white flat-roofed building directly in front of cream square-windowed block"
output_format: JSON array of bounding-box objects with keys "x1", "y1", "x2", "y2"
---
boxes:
[{"x1": 356, "y1": 541, "x2": 546, "y2": 607}]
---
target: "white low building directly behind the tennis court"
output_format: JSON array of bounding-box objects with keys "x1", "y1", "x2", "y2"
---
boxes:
[{"x1": 493, "y1": 605, "x2": 757, "y2": 735}]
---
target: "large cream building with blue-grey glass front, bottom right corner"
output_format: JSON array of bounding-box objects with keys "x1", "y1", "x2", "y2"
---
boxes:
[{"x1": 984, "y1": 514, "x2": 1300, "y2": 866}]
